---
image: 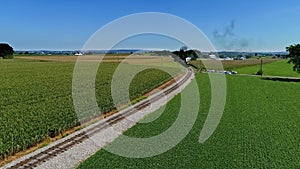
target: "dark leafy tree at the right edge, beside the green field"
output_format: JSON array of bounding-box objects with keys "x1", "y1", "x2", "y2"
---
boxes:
[{"x1": 286, "y1": 44, "x2": 300, "y2": 72}]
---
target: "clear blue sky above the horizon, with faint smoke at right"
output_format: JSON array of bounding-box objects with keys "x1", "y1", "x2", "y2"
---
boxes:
[{"x1": 0, "y1": 0, "x2": 300, "y2": 51}]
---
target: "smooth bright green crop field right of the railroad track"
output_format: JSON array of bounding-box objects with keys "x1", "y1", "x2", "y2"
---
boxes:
[{"x1": 78, "y1": 74, "x2": 300, "y2": 169}]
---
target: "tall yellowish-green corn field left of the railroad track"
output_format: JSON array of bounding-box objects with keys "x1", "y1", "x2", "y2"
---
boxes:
[{"x1": 0, "y1": 59, "x2": 179, "y2": 159}]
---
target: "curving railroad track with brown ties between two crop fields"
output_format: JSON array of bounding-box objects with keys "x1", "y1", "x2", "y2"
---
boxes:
[{"x1": 7, "y1": 69, "x2": 193, "y2": 169}]
